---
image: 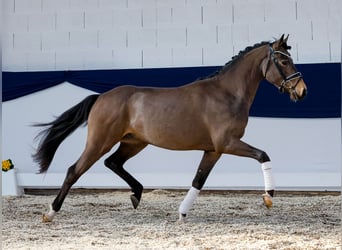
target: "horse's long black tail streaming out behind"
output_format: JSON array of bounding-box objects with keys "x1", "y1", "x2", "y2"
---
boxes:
[{"x1": 32, "y1": 95, "x2": 99, "y2": 173}]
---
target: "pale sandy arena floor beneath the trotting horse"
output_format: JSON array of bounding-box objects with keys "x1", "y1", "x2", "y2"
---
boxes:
[{"x1": 2, "y1": 190, "x2": 341, "y2": 250}]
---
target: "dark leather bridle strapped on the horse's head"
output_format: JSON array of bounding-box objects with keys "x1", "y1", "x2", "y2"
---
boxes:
[{"x1": 264, "y1": 44, "x2": 302, "y2": 93}]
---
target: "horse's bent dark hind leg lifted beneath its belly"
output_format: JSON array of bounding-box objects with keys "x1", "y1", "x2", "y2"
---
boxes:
[{"x1": 105, "y1": 140, "x2": 147, "y2": 208}]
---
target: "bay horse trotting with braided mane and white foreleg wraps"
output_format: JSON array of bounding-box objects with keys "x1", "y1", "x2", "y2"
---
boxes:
[{"x1": 33, "y1": 35, "x2": 307, "y2": 222}]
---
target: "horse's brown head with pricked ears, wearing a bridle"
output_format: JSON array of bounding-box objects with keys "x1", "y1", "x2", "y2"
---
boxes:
[{"x1": 262, "y1": 35, "x2": 307, "y2": 101}]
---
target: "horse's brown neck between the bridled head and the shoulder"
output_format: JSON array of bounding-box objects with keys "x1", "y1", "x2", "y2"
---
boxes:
[{"x1": 220, "y1": 46, "x2": 267, "y2": 107}]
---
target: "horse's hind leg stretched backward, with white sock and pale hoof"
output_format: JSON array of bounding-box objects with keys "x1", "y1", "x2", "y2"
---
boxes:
[{"x1": 43, "y1": 146, "x2": 105, "y2": 222}]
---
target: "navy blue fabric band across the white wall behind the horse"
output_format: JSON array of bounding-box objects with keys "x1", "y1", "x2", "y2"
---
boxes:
[{"x1": 2, "y1": 63, "x2": 341, "y2": 118}]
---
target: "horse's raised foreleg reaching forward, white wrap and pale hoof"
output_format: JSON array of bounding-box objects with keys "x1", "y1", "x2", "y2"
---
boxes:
[{"x1": 225, "y1": 140, "x2": 275, "y2": 208}]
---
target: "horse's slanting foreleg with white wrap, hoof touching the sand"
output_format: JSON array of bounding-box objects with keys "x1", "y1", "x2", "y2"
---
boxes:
[{"x1": 179, "y1": 152, "x2": 221, "y2": 221}]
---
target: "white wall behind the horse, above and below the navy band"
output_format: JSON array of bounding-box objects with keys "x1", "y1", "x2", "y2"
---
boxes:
[{"x1": 2, "y1": 0, "x2": 341, "y2": 190}]
